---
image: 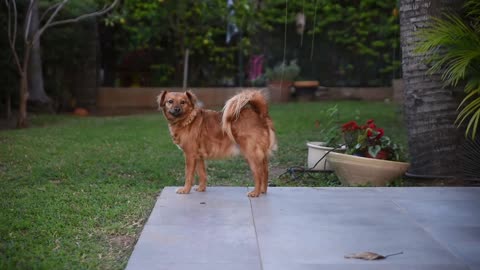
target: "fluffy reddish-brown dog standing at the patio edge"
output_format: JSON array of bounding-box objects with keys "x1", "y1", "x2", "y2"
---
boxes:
[{"x1": 157, "y1": 90, "x2": 277, "y2": 197}]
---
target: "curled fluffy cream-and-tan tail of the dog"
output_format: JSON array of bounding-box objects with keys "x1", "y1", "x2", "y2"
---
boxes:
[{"x1": 222, "y1": 90, "x2": 277, "y2": 153}]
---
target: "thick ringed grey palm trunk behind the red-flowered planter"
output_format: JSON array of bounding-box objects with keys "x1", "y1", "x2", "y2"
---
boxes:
[{"x1": 400, "y1": 0, "x2": 463, "y2": 177}]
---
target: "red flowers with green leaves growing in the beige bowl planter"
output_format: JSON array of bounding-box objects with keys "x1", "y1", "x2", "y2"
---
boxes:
[{"x1": 342, "y1": 119, "x2": 400, "y2": 160}]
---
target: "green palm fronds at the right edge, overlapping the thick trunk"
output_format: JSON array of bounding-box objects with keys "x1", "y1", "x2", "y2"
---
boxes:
[{"x1": 417, "y1": 0, "x2": 480, "y2": 139}]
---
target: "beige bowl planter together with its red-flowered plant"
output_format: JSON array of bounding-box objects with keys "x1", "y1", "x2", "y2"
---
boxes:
[{"x1": 328, "y1": 120, "x2": 409, "y2": 186}]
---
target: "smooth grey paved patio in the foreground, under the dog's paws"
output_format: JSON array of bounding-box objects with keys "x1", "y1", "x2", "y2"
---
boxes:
[{"x1": 127, "y1": 187, "x2": 480, "y2": 270}]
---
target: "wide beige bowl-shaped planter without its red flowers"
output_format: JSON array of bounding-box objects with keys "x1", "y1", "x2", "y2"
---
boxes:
[{"x1": 328, "y1": 152, "x2": 410, "y2": 186}]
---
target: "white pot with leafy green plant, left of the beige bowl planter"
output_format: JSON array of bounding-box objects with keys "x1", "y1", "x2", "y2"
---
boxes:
[{"x1": 307, "y1": 105, "x2": 345, "y2": 171}]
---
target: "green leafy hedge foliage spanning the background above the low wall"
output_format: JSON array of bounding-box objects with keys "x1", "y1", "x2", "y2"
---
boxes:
[{"x1": 98, "y1": 0, "x2": 400, "y2": 84}]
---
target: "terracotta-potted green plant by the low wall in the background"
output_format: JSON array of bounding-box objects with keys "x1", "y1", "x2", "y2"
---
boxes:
[{"x1": 265, "y1": 60, "x2": 300, "y2": 102}]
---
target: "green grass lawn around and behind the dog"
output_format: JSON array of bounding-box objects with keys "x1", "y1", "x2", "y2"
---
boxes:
[{"x1": 0, "y1": 101, "x2": 406, "y2": 269}]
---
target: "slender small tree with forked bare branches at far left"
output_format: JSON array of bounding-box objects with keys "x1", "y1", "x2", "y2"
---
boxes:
[{"x1": 4, "y1": 0, "x2": 119, "y2": 128}]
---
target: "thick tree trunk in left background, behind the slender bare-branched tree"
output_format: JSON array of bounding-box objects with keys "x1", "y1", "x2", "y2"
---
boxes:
[{"x1": 28, "y1": 1, "x2": 51, "y2": 104}]
